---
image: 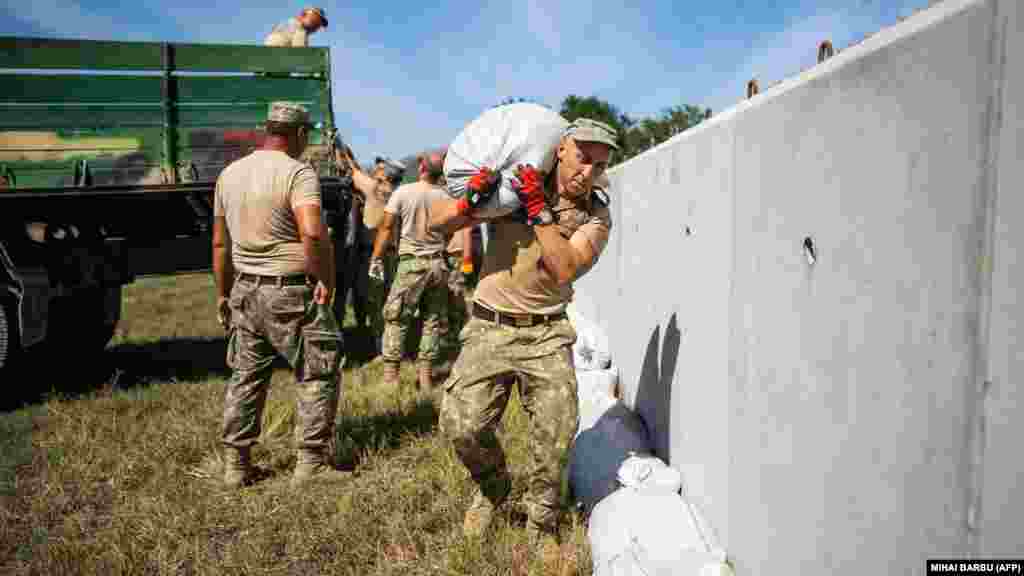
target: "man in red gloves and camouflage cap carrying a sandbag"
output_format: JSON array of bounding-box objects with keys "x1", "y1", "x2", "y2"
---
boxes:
[{"x1": 432, "y1": 119, "x2": 617, "y2": 562}]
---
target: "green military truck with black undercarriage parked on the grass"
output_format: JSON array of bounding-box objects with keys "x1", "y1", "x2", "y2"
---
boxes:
[{"x1": 0, "y1": 37, "x2": 345, "y2": 374}]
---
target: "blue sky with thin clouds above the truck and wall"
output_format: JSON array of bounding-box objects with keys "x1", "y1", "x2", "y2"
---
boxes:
[{"x1": 0, "y1": 0, "x2": 929, "y2": 158}]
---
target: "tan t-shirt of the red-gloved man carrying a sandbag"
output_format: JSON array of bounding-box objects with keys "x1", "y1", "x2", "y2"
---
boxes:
[{"x1": 473, "y1": 189, "x2": 611, "y2": 314}]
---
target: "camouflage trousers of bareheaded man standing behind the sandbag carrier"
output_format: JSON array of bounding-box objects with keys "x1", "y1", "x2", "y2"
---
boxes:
[{"x1": 381, "y1": 256, "x2": 449, "y2": 364}]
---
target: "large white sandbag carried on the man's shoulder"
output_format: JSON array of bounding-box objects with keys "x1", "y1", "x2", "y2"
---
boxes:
[{"x1": 444, "y1": 102, "x2": 568, "y2": 219}]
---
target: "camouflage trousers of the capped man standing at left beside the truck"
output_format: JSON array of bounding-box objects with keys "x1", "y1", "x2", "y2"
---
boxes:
[{"x1": 221, "y1": 278, "x2": 344, "y2": 449}]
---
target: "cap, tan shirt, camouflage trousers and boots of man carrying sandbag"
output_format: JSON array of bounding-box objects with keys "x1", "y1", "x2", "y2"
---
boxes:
[{"x1": 439, "y1": 119, "x2": 615, "y2": 537}]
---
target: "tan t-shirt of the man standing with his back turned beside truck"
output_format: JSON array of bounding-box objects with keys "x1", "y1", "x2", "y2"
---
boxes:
[{"x1": 213, "y1": 150, "x2": 321, "y2": 276}]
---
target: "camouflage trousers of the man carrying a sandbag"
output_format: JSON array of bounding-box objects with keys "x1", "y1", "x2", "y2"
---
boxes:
[{"x1": 439, "y1": 318, "x2": 579, "y2": 532}]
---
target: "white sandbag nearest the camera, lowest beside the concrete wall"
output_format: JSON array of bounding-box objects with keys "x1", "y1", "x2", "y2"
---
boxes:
[{"x1": 587, "y1": 488, "x2": 731, "y2": 576}]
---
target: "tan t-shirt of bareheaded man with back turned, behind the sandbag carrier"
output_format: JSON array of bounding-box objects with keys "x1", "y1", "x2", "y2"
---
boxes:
[{"x1": 384, "y1": 180, "x2": 447, "y2": 256}]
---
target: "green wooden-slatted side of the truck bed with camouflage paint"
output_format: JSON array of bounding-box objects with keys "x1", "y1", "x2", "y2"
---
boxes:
[{"x1": 0, "y1": 38, "x2": 333, "y2": 189}]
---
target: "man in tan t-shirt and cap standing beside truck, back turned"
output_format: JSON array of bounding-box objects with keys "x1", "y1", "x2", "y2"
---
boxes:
[{"x1": 213, "y1": 102, "x2": 343, "y2": 487}]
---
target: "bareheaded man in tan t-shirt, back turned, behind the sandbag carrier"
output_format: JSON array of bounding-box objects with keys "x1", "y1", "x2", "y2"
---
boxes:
[{"x1": 370, "y1": 152, "x2": 449, "y2": 388}]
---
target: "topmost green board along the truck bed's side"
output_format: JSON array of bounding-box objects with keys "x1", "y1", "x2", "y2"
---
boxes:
[{"x1": 0, "y1": 37, "x2": 328, "y2": 77}]
